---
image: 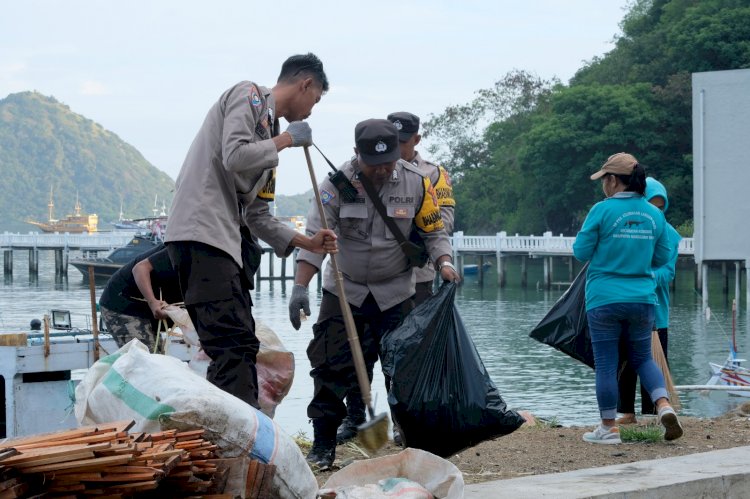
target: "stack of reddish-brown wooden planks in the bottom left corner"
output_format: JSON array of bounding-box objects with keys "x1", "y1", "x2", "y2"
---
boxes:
[{"x1": 0, "y1": 421, "x2": 244, "y2": 499}]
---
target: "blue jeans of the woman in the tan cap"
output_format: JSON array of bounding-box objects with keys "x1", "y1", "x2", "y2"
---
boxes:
[{"x1": 586, "y1": 303, "x2": 668, "y2": 419}]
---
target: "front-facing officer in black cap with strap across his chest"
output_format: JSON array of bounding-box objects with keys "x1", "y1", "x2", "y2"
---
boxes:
[{"x1": 289, "y1": 119, "x2": 459, "y2": 468}]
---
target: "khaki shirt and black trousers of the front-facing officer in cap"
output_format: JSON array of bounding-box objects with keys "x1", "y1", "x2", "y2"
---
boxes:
[{"x1": 297, "y1": 159, "x2": 451, "y2": 426}]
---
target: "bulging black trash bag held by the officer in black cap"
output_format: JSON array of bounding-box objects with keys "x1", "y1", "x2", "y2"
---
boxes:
[{"x1": 380, "y1": 283, "x2": 524, "y2": 457}]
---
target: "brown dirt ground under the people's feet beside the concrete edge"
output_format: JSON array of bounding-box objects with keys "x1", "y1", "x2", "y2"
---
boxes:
[{"x1": 304, "y1": 402, "x2": 750, "y2": 485}]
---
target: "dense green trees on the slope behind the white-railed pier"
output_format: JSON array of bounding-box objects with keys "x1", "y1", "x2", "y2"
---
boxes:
[{"x1": 423, "y1": 0, "x2": 750, "y2": 236}]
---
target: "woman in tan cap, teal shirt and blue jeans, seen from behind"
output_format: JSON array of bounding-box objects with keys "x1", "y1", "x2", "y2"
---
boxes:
[{"x1": 573, "y1": 153, "x2": 683, "y2": 444}]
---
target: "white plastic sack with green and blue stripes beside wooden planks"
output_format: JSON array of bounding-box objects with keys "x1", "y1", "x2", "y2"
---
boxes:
[{"x1": 75, "y1": 340, "x2": 318, "y2": 498}]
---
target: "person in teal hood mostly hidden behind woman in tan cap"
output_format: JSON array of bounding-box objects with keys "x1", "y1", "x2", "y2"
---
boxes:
[{"x1": 617, "y1": 177, "x2": 682, "y2": 424}]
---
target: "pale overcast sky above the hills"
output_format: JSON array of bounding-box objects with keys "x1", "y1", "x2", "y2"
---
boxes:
[{"x1": 0, "y1": 0, "x2": 628, "y2": 199}]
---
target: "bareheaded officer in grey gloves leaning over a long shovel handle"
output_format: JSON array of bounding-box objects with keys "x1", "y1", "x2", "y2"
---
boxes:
[{"x1": 165, "y1": 54, "x2": 336, "y2": 408}]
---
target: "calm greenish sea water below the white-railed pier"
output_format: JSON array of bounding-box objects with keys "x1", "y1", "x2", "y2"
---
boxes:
[{"x1": 0, "y1": 252, "x2": 750, "y2": 435}]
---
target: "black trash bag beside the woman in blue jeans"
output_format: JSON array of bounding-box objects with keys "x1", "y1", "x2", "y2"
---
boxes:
[{"x1": 529, "y1": 263, "x2": 594, "y2": 368}]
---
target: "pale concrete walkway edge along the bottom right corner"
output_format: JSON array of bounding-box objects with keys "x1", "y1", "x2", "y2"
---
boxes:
[{"x1": 465, "y1": 447, "x2": 750, "y2": 499}]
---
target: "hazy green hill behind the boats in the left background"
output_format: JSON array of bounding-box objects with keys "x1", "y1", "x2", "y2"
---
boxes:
[{"x1": 0, "y1": 92, "x2": 174, "y2": 232}]
